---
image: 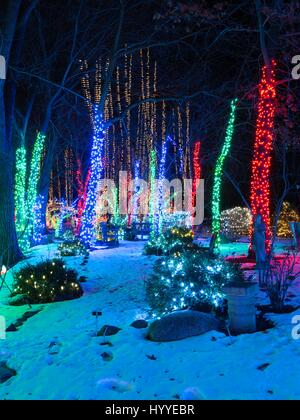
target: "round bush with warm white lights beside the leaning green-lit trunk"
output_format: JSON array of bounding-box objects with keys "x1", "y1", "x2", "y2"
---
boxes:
[{"x1": 221, "y1": 207, "x2": 252, "y2": 239}]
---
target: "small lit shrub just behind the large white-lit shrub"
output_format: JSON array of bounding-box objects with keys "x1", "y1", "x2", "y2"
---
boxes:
[{"x1": 144, "y1": 226, "x2": 198, "y2": 256}]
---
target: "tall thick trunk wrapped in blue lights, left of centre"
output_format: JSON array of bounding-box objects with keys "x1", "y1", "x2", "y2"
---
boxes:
[{"x1": 80, "y1": 105, "x2": 105, "y2": 246}]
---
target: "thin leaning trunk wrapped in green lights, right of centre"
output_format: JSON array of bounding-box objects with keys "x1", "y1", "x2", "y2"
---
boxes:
[{"x1": 212, "y1": 98, "x2": 238, "y2": 248}]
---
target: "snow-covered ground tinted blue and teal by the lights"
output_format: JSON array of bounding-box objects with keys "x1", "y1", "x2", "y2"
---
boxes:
[{"x1": 0, "y1": 242, "x2": 300, "y2": 400}]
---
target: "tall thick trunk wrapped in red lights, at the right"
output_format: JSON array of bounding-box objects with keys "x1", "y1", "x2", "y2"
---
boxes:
[{"x1": 250, "y1": 60, "x2": 276, "y2": 252}]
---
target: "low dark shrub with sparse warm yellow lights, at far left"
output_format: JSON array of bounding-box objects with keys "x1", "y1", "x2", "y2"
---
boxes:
[{"x1": 13, "y1": 258, "x2": 83, "y2": 304}]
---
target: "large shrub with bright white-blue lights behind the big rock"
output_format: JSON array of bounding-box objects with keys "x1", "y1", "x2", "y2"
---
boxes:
[{"x1": 145, "y1": 248, "x2": 244, "y2": 318}]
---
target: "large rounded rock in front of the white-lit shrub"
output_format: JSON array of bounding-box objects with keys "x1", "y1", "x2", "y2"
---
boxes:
[{"x1": 147, "y1": 310, "x2": 220, "y2": 341}]
